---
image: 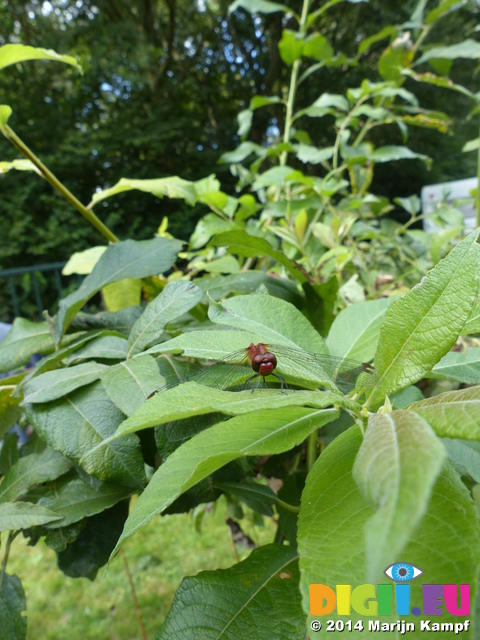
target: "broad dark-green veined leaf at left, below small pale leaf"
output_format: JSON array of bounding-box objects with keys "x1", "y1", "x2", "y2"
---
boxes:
[{"x1": 27, "y1": 382, "x2": 145, "y2": 488}]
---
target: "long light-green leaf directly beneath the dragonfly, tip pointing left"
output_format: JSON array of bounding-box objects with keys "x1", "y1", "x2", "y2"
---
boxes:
[{"x1": 112, "y1": 382, "x2": 342, "y2": 440}]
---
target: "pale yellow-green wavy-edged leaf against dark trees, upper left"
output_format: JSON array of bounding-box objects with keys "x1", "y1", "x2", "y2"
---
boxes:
[{"x1": 89, "y1": 175, "x2": 220, "y2": 206}]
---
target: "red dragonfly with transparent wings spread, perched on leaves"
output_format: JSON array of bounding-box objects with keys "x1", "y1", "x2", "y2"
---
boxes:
[{"x1": 147, "y1": 342, "x2": 380, "y2": 399}]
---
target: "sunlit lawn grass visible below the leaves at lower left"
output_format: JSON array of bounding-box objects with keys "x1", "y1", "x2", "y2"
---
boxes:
[{"x1": 7, "y1": 499, "x2": 274, "y2": 640}]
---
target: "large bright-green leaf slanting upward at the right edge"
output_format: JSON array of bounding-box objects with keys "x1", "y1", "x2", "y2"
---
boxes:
[{"x1": 369, "y1": 231, "x2": 480, "y2": 406}]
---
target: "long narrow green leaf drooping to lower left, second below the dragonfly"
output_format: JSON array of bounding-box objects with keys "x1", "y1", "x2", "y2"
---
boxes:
[{"x1": 111, "y1": 407, "x2": 339, "y2": 551}]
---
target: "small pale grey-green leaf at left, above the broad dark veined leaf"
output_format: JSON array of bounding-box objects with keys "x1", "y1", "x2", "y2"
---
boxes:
[{"x1": 23, "y1": 362, "x2": 106, "y2": 404}]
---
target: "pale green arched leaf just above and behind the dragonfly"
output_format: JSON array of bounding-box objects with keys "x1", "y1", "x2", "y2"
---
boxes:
[{"x1": 208, "y1": 294, "x2": 327, "y2": 353}]
